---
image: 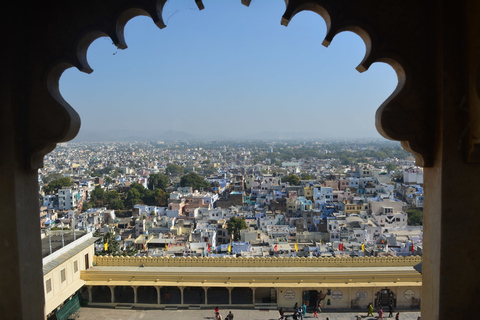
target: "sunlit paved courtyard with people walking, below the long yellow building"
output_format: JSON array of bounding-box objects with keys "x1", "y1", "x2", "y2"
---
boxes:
[{"x1": 77, "y1": 307, "x2": 420, "y2": 320}]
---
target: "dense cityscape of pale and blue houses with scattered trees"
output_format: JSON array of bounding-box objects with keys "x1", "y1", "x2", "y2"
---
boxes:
[{"x1": 39, "y1": 140, "x2": 423, "y2": 256}]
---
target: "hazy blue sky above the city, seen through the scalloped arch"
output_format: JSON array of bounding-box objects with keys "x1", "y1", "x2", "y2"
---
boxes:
[{"x1": 60, "y1": 0, "x2": 397, "y2": 138}]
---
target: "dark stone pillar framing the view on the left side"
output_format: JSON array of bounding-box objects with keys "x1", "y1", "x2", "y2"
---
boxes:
[{"x1": 0, "y1": 127, "x2": 45, "y2": 319}]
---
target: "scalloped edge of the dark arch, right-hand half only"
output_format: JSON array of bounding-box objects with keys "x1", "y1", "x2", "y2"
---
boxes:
[{"x1": 282, "y1": 0, "x2": 433, "y2": 167}]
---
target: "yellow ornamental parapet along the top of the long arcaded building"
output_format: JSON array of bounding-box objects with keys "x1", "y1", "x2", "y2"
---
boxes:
[{"x1": 93, "y1": 256, "x2": 422, "y2": 268}]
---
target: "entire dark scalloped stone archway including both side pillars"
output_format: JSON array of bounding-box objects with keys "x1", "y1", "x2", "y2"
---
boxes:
[{"x1": 5, "y1": 0, "x2": 480, "y2": 320}]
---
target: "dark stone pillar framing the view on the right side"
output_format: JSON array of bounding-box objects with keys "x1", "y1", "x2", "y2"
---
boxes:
[{"x1": 421, "y1": 1, "x2": 480, "y2": 320}]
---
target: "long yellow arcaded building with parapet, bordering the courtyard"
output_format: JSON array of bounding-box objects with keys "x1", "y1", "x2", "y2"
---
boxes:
[{"x1": 81, "y1": 256, "x2": 422, "y2": 309}]
